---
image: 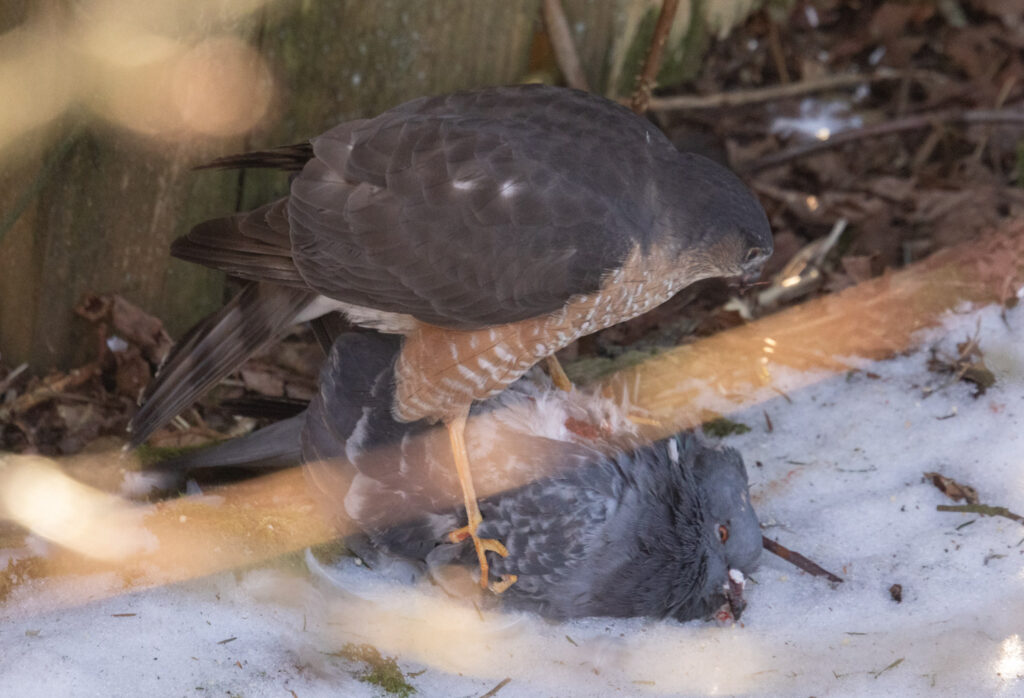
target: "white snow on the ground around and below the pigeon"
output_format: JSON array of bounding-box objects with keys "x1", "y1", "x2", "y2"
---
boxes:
[{"x1": 0, "y1": 300, "x2": 1024, "y2": 698}]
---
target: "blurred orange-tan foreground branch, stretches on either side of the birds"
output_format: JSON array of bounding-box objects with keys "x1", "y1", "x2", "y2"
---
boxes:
[{"x1": 0, "y1": 221, "x2": 1024, "y2": 603}]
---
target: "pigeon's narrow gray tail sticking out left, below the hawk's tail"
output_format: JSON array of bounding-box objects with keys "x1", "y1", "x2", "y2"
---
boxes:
[{"x1": 152, "y1": 415, "x2": 305, "y2": 472}]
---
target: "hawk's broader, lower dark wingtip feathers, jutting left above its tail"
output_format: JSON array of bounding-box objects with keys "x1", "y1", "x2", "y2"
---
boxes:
[{"x1": 171, "y1": 198, "x2": 306, "y2": 289}]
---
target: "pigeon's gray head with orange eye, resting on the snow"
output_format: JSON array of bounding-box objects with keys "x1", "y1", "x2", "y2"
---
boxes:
[{"x1": 675, "y1": 436, "x2": 761, "y2": 620}]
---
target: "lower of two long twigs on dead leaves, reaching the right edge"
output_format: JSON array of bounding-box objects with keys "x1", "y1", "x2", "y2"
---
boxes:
[{"x1": 739, "y1": 103, "x2": 1024, "y2": 172}]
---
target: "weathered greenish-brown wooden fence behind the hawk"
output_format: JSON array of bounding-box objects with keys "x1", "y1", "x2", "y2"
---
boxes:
[{"x1": 0, "y1": 0, "x2": 761, "y2": 373}]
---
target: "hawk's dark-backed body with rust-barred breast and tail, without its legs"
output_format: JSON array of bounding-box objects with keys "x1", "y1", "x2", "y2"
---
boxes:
[{"x1": 132, "y1": 85, "x2": 772, "y2": 443}]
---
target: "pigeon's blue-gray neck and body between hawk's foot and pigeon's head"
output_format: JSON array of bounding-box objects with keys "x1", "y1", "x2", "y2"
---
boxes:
[{"x1": 480, "y1": 439, "x2": 725, "y2": 618}]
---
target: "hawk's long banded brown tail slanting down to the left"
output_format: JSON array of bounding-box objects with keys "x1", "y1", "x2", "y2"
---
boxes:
[{"x1": 129, "y1": 283, "x2": 316, "y2": 447}]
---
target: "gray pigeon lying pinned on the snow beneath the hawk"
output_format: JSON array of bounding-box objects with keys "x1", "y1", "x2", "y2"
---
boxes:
[{"x1": 153, "y1": 334, "x2": 761, "y2": 620}]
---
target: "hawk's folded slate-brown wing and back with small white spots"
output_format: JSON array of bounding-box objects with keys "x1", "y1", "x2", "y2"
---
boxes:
[{"x1": 289, "y1": 86, "x2": 671, "y2": 329}]
